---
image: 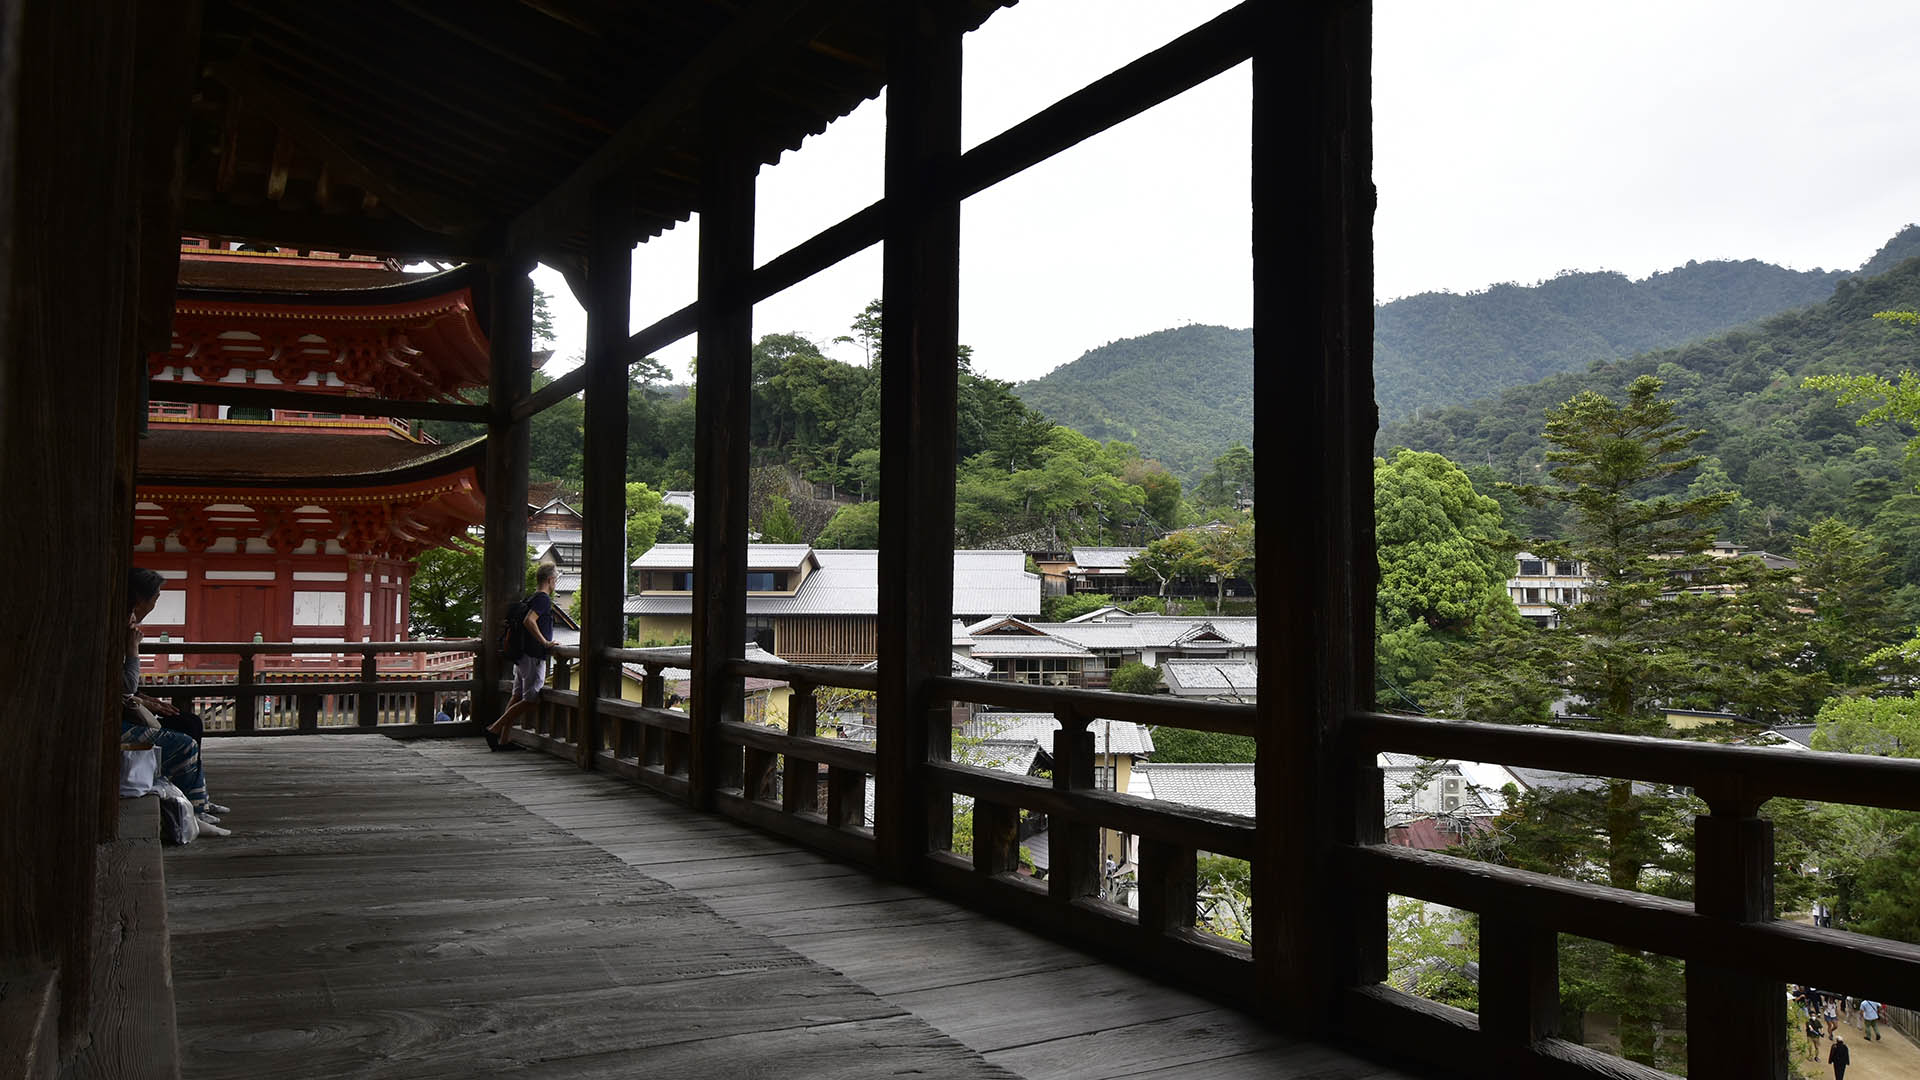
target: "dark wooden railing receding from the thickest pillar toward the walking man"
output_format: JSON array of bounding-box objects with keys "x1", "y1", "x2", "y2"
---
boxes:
[{"x1": 516, "y1": 648, "x2": 1256, "y2": 994}]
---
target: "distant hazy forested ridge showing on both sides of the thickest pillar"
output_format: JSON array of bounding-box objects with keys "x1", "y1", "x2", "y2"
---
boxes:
[{"x1": 1014, "y1": 225, "x2": 1920, "y2": 480}]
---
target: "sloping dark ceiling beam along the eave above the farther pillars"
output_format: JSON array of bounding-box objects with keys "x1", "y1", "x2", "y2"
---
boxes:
[{"x1": 505, "y1": 0, "x2": 854, "y2": 250}]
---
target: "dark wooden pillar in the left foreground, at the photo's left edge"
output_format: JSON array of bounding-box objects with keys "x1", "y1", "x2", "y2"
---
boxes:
[{"x1": 0, "y1": 0, "x2": 196, "y2": 1045}]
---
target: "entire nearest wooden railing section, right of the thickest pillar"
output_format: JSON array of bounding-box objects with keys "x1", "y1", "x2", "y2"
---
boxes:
[{"x1": 1338, "y1": 713, "x2": 1920, "y2": 1076}]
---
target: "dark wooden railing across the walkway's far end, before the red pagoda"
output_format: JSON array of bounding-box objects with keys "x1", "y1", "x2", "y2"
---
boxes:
[{"x1": 140, "y1": 640, "x2": 480, "y2": 736}]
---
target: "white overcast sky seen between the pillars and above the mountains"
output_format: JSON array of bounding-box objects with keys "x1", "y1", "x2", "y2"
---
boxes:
[{"x1": 536, "y1": 0, "x2": 1920, "y2": 380}]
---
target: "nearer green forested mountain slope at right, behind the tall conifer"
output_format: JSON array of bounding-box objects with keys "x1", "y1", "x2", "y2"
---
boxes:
[{"x1": 1379, "y1": 247, "x2": 1920, "y2": 615}]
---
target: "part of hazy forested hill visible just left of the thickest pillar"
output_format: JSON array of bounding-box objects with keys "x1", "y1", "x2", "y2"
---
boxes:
[{"x1": 1014, "y1": 319, "x2": 1254, "y2": 480}]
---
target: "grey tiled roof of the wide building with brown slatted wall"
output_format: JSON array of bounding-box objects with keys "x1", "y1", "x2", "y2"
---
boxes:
[{"x1": 626, "y1": 544, "x2": 1041, "y2": 617}]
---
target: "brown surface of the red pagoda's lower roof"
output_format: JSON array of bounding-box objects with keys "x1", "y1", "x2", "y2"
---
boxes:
[{"x1": 134, "y1": 423, "x2": 486, "y2": 488}]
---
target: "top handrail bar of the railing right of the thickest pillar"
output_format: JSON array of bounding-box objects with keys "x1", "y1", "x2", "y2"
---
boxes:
[{"x1": 1346, "y1": 713, "x2": 1920, "y2": 811}]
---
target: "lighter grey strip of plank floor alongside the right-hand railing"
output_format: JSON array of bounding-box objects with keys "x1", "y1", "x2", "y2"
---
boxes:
[{"x1": 413, "y1": 740, "x2": 1428, "y2": 1080}]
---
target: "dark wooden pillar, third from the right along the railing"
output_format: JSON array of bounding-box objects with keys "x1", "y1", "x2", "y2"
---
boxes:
[{"x1": 687, "y1": 102, "x2": 758, "y2": 809}]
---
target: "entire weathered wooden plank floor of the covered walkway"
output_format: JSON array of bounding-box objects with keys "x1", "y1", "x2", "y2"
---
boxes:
[{"x1": 167, "y1": 736, "x2": 1402, "y2": 1080}]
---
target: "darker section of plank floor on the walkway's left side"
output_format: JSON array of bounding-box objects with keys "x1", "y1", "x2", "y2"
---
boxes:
[{"x1": 165, "y1": 736, "x2": 1008, "y2": 1080}]
